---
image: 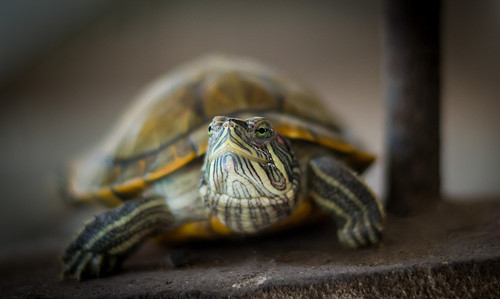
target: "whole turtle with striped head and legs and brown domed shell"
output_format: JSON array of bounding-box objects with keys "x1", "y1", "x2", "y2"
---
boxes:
[{"x1": 62, "y1": 55, "x2": 384, "y2": 280}]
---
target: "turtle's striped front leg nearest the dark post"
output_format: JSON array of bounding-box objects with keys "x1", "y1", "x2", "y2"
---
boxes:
[{"x1": 308, "y1": 156, "x2": 384, "y2": 248}]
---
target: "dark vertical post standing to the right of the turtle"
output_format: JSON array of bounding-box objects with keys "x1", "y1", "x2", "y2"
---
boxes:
[{"x1": 383, "y1": 0, "x2": 440, "y2": 214}]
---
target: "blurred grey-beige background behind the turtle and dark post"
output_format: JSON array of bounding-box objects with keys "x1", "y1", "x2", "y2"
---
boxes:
[{"x1": 0, "y1": 0, "x2": 500, "y2": 244}]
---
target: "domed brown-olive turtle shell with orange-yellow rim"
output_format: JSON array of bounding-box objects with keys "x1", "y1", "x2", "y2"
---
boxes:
[{"x1": 69, "y1": 56, "x2": 374, "y2": 205}]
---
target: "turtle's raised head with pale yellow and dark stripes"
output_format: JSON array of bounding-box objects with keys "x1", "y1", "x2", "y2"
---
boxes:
[{"x1": 200, "y1": 116, "x2": 300, "y2": 233}]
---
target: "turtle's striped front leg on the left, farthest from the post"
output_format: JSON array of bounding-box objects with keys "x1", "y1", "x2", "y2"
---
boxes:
[{"x1": 62, "y1": 198, "x2": 172, "y2": 280}]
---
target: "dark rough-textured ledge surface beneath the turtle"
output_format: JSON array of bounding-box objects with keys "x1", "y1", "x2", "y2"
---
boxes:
[{"x1": 0, "y1": 201, "x2": 500, "y2": 298}]
